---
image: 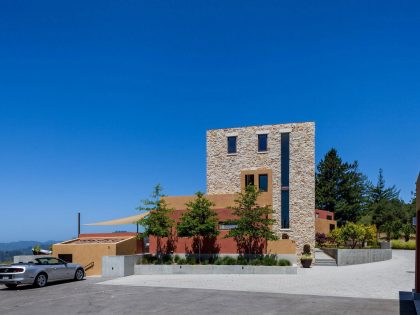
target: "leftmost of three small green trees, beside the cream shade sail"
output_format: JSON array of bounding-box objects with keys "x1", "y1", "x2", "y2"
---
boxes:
[{"x1": 137, "y1": 184, "x2": 174, "y2": 258}]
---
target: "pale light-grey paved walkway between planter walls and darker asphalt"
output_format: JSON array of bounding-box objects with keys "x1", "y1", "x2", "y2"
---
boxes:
[{"x1": 101, "y1": 250, "x2": 415, "y2": 299}]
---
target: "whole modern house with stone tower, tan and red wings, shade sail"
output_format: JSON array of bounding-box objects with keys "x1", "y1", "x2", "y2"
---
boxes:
[{"x1": 53, "y1": 122, "x2": 315, "y2": 274}]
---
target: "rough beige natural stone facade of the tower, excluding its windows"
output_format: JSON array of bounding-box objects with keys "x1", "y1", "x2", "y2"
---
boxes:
[{"x1": 207, "y1": 122, "x2": 315, "y2": 254}]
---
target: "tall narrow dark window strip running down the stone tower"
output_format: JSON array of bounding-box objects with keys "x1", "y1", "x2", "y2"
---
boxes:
[{"x1": 281, "y1": 133, "x2": 290, "y2": 229}]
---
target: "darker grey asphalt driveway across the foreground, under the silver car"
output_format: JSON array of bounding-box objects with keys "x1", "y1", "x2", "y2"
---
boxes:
[{"x1": 0, "y1": 278, "x2": 415, "y2": 315}]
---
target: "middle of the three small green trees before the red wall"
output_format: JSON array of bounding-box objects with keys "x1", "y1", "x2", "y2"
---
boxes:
[{"x1": 177, "y1": 192, "x2": 219, "y2": 262}]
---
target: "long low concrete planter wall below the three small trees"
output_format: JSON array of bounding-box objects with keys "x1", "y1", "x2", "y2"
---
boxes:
[{"x1": 134, "y1": 265, "x2": 297, "y2": 275}]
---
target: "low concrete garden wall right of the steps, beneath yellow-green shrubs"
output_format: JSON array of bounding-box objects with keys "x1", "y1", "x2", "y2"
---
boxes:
[{"x1": 322, "y1": 248, "x2": 392, "y2": 266}]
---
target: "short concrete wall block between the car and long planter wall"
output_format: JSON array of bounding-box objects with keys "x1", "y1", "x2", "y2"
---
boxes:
[{"x1": 102, "y1": 255, "x2": 143, "y2": 277}]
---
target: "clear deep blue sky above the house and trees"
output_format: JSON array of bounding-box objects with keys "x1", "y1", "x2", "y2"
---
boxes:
[{"x1": 0, "y1": 0, "x2": 420, "y2": 242}]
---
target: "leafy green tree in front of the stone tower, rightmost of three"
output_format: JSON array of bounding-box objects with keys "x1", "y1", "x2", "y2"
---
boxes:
[{"x1": 225, "y1": 185, "x2": 278, "y2": 254}]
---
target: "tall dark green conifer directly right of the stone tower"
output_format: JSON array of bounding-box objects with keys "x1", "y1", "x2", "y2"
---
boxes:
[{"x1": 315, "y1": 148, "x2": 367, "y2": 226}]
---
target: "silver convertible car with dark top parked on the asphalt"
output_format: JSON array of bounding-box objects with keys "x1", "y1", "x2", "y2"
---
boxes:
[{"x1": 0, "y1": 257, "x2": 85, "y2": 289}]
